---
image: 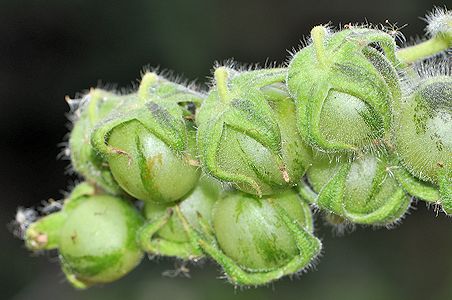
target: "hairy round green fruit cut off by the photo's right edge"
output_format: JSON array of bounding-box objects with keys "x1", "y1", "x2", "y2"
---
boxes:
[{"x1": 394, "y1": 76, "x2": 452, "y2": 214}]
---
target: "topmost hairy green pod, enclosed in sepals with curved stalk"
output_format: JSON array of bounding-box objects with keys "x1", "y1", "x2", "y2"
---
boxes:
[{"x1": 287, "y1": 26, "x2": 400, "y2": 152}]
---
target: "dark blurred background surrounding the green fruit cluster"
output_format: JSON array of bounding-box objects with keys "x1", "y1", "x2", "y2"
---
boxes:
[{"x1": 0, "y1": 0, "x2": 452, "y2": 300}]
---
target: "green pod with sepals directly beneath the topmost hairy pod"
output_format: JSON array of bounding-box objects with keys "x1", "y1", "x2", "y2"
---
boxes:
[{"x1": 306, "y1": 155, "x2": 411, "y2": 225}]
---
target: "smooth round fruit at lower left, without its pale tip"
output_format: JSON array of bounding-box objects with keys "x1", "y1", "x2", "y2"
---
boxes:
[{"x1": 59, "y1": 195, "x2": 143, "y2": 287}]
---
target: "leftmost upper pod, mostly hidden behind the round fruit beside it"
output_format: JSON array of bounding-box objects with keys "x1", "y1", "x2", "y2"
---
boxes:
[{"x1": 68, "y1": 89, "x2": 134, "y2": 194}]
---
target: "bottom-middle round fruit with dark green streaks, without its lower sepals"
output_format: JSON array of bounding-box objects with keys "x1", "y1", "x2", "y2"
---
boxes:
[{"x1": 213, "y1": 191, "x2": 312, "y2": 272}]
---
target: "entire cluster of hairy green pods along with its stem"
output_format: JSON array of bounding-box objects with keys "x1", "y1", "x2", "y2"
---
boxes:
[{"x1": 18, "y1": 9, "x2": 452, "y2": 288}]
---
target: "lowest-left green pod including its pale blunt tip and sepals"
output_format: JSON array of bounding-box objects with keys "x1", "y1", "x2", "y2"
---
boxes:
[{"x1": 25, "y1": 184, "x2": 143, "y2": 288}]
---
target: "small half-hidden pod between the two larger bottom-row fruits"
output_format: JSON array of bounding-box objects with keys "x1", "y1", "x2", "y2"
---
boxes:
[{"x1": 139, "y1": 177, "x2": 221, "y2": 259}]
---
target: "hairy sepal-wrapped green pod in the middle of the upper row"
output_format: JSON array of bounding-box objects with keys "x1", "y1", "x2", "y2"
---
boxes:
[{"x1": 196, "y1": 67, "x2": 310, "y2": 196}]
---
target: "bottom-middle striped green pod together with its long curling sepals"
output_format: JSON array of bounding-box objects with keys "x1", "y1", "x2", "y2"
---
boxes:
[{"x1": 177, "y1": 190, "x2": 321, "y2": 285}]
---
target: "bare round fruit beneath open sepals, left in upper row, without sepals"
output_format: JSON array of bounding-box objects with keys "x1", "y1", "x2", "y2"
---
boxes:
[{"x1": 107, "y1": 121, "x2": 199, "y2": 202}]
